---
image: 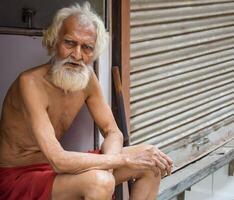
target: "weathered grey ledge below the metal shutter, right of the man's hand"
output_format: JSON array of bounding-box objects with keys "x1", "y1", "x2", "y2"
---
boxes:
[{"x1": 157, "y1": 139, "x2": 234, "y2": 200}]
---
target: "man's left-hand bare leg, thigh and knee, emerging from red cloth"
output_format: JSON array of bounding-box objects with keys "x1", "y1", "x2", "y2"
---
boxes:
[{"x1": 52, "y1": 170, "x2": 115, "y2": 200}]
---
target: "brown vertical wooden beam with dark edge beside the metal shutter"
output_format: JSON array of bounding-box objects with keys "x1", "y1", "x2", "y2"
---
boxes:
[{"x1": 111, "y1": 0, "x2": 130, "y2": 131}]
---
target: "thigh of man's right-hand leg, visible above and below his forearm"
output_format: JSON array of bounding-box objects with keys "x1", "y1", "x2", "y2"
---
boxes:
[{"x1": 113, "y1": 144, "x2": 153, "y2": 185}]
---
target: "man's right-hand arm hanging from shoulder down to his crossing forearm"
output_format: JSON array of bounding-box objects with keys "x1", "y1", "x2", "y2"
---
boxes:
[{"x1": 86, "y1": 73, "x2": 123, "y2": 154}]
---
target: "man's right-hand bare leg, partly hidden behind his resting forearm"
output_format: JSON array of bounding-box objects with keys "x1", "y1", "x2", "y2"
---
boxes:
[{"x1": 113, "y1": 145, "x2": 161, "y2": 200}]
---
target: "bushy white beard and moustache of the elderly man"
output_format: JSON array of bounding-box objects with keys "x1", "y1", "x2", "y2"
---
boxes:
[{"x1": 52, "y1": 58, "x2": 93, "y2": 92}]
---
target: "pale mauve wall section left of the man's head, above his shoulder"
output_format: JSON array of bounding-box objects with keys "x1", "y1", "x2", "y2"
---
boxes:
[{"x1": 0, "y1": 35, "x2": 49, "y2": 108}]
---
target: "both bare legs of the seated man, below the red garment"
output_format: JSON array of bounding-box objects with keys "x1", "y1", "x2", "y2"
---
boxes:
[{"x1": 52, "y1": 145, "x2": 161, "y2": 200}]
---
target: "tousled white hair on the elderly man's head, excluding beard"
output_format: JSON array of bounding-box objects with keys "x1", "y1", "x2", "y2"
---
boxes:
[{"x1": 42, "y1": 2, "x2": 108, "y2": 60}]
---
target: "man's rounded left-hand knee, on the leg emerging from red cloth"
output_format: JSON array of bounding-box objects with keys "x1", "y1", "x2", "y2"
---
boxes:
[{"x1": 87, "y1": 170, "x2": 115, "y2": 199}]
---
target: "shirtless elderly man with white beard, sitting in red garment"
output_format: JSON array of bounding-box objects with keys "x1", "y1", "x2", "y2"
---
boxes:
[{"x1": 0, "y1": 3, "x2": 172, "y2": 200}]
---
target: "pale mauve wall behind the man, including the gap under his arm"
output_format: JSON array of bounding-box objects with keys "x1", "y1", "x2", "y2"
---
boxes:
[{"x1": 0, "y1": 35, "x2": 94, "y2": 151}]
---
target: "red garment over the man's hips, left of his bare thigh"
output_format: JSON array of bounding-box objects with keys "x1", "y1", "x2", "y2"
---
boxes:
[{"x1": 0, "y1": 164, "x2": 56, "y2": 200}]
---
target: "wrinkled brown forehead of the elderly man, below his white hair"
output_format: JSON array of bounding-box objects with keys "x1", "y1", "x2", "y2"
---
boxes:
[{"x1": 59, "y1": 15, "x2": 97, "y2": 42}]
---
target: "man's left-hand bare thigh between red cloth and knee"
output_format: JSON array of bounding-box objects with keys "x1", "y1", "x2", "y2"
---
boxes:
[{"x1": 52, "y1": 170, "x2": 107, "y2": 200}]
